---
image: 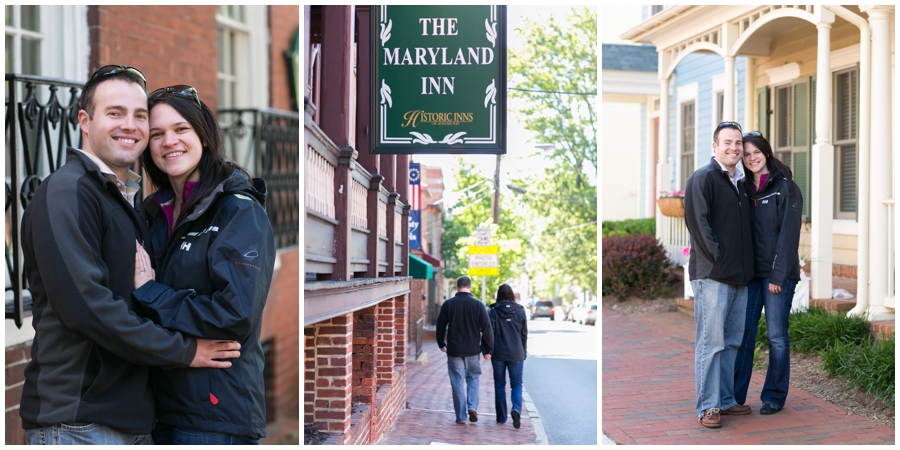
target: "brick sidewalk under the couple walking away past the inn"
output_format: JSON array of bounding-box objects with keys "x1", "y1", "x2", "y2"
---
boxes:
[{"x1": 379, "y1": 342, "x2": 536, "y2": 445}]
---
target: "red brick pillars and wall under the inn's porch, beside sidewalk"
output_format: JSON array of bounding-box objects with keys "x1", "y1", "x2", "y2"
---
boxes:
[{"x1": 303, "y1": 295, "x2": 408, "y2": 445}]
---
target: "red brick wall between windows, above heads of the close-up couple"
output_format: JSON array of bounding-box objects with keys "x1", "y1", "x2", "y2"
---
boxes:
[{"x1": 85, "y1": 5, "x2": 220, "y2": 111}]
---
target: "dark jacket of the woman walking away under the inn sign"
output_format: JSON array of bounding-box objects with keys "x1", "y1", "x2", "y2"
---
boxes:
[{"x1": 488, "y1": 301, "x2": 528, "y2": 361}]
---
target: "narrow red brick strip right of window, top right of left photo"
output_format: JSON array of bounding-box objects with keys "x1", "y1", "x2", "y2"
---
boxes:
[{"x1": 269, "y1": 5, "x2": 303, "y2": 111}]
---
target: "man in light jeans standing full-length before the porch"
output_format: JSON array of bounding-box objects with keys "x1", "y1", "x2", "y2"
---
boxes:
[{"x1": 684, "y1": 122, "x2": 753, "y2": 428}]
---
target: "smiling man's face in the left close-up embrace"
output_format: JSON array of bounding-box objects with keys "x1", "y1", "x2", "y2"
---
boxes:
[{"x1": 78, "y1": 80, "x2": 150, "y2": 179}]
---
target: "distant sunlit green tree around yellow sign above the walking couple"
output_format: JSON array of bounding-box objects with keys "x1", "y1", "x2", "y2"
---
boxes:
[{"x1": 441, "y1": 158, "x2": 525, "y2": 304}]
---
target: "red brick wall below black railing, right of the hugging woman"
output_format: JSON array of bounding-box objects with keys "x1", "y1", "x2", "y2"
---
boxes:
[{"x1": 260, "y1": 248, "x2": 300, "y2": 419}]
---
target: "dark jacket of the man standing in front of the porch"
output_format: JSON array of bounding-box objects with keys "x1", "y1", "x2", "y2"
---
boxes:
[{"x1": 684, "y1": 157, "x2": 753, "y2": 286}]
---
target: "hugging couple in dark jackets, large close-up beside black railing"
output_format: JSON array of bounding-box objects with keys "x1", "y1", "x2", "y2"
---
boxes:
[{"x1": 20, "y1": 65, "x2": 275, "y2": 445}]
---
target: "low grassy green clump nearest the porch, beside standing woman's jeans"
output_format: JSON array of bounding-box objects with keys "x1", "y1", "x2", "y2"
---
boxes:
[{"x1": 788, "y1": 308, "x2": 869, "y2": 353}]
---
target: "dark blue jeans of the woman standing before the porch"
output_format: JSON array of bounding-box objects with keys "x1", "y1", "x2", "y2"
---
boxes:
[{"x1": 734, "y1": 278, "x2": 797, "y2": 409}]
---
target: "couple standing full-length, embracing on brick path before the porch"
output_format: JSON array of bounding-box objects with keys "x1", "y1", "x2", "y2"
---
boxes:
[{"x1": 684, "y1": 122, "x2": 803, "y2": 428}]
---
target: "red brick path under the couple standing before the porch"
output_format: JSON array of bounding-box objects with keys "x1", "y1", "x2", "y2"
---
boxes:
[{"x1": 601, "y1": 308, "x2": 894, "y2": 445}]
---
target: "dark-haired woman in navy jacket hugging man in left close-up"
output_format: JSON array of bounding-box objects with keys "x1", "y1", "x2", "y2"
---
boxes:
[{"x1": 132, "y1": 85, "x2": 275, "y2": 445}]
